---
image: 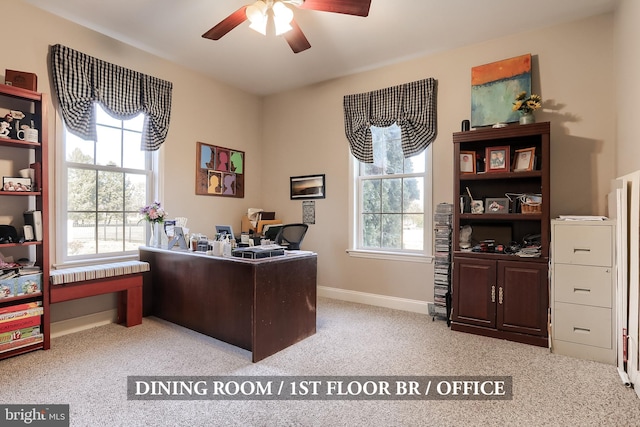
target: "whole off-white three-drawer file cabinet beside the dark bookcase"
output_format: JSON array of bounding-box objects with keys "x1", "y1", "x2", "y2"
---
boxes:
[{"x1": 551, "y1": 220, "x2": 616, "y2": 365}]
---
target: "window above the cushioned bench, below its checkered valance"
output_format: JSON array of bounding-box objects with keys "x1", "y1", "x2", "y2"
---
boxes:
[{"x1": 58, "y1": 104, "x2": 154, "y2": 262}]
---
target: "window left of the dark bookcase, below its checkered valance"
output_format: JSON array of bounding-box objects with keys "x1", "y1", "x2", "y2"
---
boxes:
[{"x1": 352, "y1": 124, "x2": 431, "y2": 256}]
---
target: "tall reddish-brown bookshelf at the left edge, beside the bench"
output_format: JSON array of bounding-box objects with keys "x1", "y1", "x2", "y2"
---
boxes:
[{"x1": 0, "y1": 84, "x2": 50, "y2": 359}]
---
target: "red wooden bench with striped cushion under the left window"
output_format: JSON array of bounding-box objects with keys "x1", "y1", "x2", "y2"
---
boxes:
[{"x1": 49, "y1": 261, "x2": 149, "y2": 327}]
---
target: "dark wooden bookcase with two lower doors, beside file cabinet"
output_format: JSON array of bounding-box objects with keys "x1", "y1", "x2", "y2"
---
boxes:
[{"x1": 451, "y1": 122, "x2": 550, "y2": 346}]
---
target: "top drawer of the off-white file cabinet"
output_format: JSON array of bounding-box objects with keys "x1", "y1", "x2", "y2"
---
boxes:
[{"x1": 552, "y1": 224, "x2": 613, "y2": 266}]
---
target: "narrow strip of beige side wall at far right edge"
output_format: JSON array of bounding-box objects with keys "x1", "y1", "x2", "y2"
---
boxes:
[{"x1": 614, "y1": 0, "x2": 640, "y2": 176}]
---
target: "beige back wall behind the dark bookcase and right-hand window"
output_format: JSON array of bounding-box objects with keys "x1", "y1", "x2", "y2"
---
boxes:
[{"x1": 263, "y1": 15, "x2": 615, "y2": 301}]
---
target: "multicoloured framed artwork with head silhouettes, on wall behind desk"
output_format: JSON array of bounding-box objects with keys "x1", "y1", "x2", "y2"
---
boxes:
[{"x1": 196, "y1": 142, "x2": 245, "y2": 198}]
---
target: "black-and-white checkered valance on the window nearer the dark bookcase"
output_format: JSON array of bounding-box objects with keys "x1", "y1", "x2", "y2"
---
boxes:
[{"x1": 344, "y1": 78, "x2": 437, "y2": 163}]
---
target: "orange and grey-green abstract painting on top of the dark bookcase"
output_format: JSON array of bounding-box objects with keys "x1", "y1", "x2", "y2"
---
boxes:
[{"x1": 471, "y1": 54, "x2": 531, "y2": 127}]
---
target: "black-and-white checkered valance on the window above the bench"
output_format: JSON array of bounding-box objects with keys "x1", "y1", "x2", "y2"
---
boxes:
[{"x1": 50, "y1": 44, "x2": 173, "y2": 151}]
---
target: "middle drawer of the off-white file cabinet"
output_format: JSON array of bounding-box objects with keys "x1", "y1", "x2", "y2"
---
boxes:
[{"x1": 553, "y1": 264, "x2": 613, "y2": 308}]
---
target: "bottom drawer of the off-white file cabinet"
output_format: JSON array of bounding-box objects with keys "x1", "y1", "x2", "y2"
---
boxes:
[{"x1": 552, "y1": 302, "x2": 612, "y2": 348}]
